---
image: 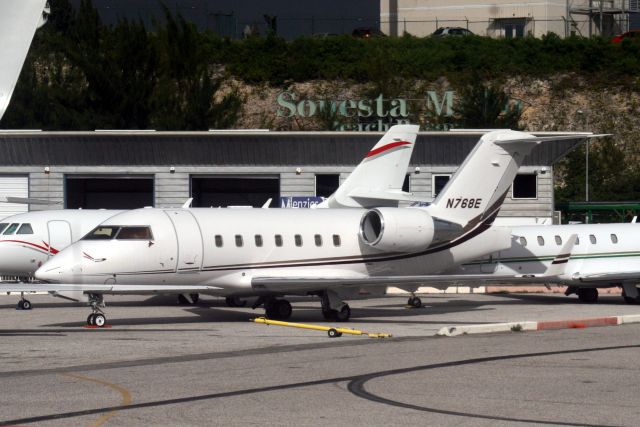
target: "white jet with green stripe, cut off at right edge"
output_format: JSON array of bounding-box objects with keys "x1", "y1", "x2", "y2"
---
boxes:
[{"x1": 443, "y1": 223, "x2": 640, "y2": 303}]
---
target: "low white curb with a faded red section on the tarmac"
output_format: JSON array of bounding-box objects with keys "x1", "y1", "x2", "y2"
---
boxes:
[{"x1": 436, "y1": 314, "x2": 640, "y2": 337}]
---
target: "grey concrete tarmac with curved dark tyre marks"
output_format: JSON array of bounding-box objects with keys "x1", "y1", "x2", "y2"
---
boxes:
[{"x1": 0, "y1": 294, "x2": 640, "y2": 426}]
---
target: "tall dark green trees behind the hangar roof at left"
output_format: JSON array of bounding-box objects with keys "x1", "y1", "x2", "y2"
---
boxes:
[{"x1": 2, "y1": 0, "x2": 242, "y2": 130}]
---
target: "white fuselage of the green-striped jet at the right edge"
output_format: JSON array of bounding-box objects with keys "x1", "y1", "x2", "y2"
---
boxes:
[{"x1": 447, "y1": 223, "x2": 640, "y2": 284}]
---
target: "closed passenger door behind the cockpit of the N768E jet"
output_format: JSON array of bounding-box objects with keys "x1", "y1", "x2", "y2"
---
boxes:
[{"x1": 166, "y1": 209, "x2": 202, "y2": 272}]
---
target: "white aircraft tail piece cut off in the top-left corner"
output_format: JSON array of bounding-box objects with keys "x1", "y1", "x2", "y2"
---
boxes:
[{"x1": 0, "y1": 0, "x2": 48, "y2": 119}]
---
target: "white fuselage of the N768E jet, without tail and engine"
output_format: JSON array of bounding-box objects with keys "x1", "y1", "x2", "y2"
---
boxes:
[{"x1": 36, "y1": 208, "x2": 509, "y2": 295}]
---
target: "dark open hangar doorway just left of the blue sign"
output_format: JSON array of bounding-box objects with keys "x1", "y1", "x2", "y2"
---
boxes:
[{"x1": 191, "y1": 175, "x2": 280, "y2": 208}]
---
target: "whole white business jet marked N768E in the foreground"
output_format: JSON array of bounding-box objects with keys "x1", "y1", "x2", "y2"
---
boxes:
[{"x1": 23, "y1": 130, "x2": 552, "y2": 326}]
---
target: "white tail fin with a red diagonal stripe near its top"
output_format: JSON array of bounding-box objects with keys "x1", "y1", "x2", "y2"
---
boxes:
[{"x1": 318, "y1": 125, "x2": 419, "y2": 208}]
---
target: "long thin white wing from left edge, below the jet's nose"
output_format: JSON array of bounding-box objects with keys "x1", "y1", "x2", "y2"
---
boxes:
[{"x1": 0, "y1": 283, "x2": 221, "y2": 294}]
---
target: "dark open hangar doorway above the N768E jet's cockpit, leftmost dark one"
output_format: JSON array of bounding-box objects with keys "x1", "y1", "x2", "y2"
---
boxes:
[{"x1": 65, "y1": 175, "x2": 153, "y2": 209}]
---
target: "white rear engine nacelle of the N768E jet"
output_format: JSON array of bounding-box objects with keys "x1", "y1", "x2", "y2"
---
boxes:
[{"x1": 360, "y1": 208, "x2": 435, "y2": 252}]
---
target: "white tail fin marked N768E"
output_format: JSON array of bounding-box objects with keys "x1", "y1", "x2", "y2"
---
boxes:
[{"x1": 426, "y1": 130, "x2": 540, "y2": 227}]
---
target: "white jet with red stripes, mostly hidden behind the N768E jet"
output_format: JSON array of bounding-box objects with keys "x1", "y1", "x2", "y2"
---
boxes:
[{"x1": 0, "y1": 125, "x2": 418, "y2": 309}]
